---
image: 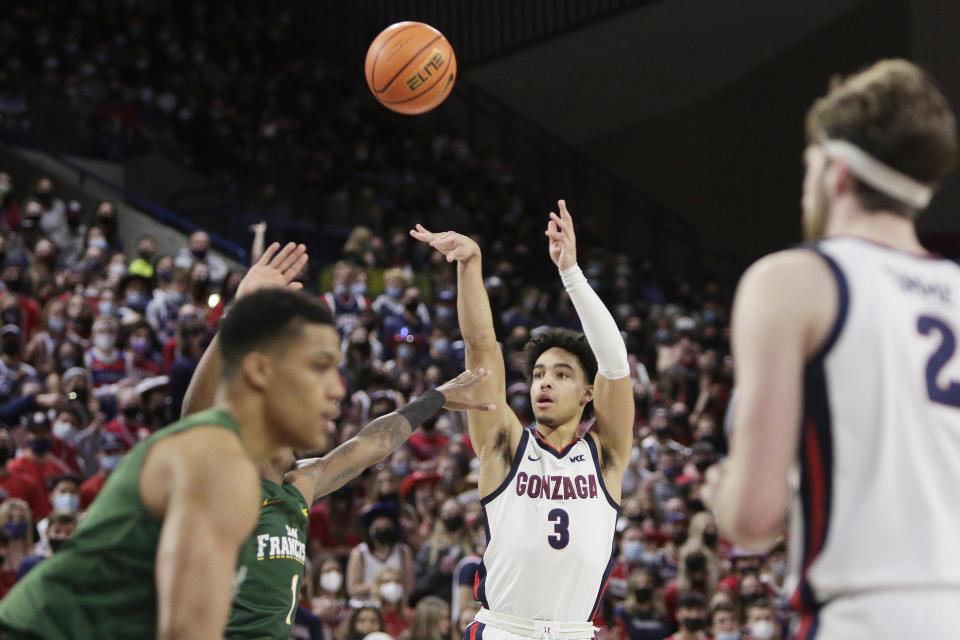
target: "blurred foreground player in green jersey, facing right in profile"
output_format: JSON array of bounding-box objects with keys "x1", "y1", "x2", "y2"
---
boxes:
[{"x1": 0, "y1": 244, "x2": 344, "y2": 640}]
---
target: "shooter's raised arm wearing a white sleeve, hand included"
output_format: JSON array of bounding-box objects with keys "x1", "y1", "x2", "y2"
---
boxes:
[{"x1": 544, "y1": 200, "x2": 634, "y2": 476}]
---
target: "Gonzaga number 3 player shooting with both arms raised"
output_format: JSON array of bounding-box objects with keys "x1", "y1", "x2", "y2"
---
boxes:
[{"x1": 410, "y1": 200, "x2": 634, "y2": 640}]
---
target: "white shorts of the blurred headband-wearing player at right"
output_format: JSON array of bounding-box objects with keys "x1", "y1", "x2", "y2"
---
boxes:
[{"x1": 796, "y1": 589, "x2": 960, "y2": 640}]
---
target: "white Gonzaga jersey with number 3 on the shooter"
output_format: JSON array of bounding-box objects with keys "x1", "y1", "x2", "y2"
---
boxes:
[{"x1": 474, "y1": 427, "x2": 620, "y2": 622}]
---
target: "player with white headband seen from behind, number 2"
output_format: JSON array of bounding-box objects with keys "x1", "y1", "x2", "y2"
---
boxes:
[{"x1": 705, "y1": 60, "x2": 960, "y2": 640}]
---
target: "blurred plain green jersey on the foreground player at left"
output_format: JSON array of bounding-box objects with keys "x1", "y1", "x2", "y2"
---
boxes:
[{"x1": 0, "y1": 409, "x2": 240, "y2": 640}]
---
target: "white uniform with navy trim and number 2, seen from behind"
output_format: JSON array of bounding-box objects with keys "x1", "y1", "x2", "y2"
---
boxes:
[{"x1": 790, "y1": 237, "x2": 960, "y2": 638}]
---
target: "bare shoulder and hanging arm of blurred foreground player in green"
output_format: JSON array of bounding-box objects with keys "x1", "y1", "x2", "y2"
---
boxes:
[{"x1": 148, "y1": 427, "x2": 260, "y2": 640}]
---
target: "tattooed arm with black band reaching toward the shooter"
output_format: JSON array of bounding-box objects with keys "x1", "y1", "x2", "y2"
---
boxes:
[{"x1": 284, "y1": 369, "x2": 495, "y2": 503}]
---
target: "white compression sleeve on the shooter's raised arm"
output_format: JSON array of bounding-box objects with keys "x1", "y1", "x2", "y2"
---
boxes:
[{"x1": 560, "y1": 265, "x2": 630, "y2": 380}]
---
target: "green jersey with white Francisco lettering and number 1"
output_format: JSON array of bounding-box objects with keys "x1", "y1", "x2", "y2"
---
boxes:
[{"x1": 226, "y1": 479, "x2": 307, "y2": 640}]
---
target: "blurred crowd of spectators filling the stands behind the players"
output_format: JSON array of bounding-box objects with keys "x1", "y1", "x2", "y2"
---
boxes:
[{"x1": 0, "y1": 1, "x2": 787, "y2": 640}]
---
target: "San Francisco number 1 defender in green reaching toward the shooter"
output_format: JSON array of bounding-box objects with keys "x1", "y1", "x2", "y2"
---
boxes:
[{"x1": 183, "y1": 292, "x2": 494, "y2": 640}]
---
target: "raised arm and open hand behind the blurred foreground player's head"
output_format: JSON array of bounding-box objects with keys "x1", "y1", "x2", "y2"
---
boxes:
[{"x1": 180, "y1": 242, "x2": 307, "y2": 417}]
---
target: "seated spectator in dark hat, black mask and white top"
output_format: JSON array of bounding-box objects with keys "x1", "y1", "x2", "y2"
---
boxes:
[{"x1": 347, "y1": 502, "x2": 413, "y2": 600}]
